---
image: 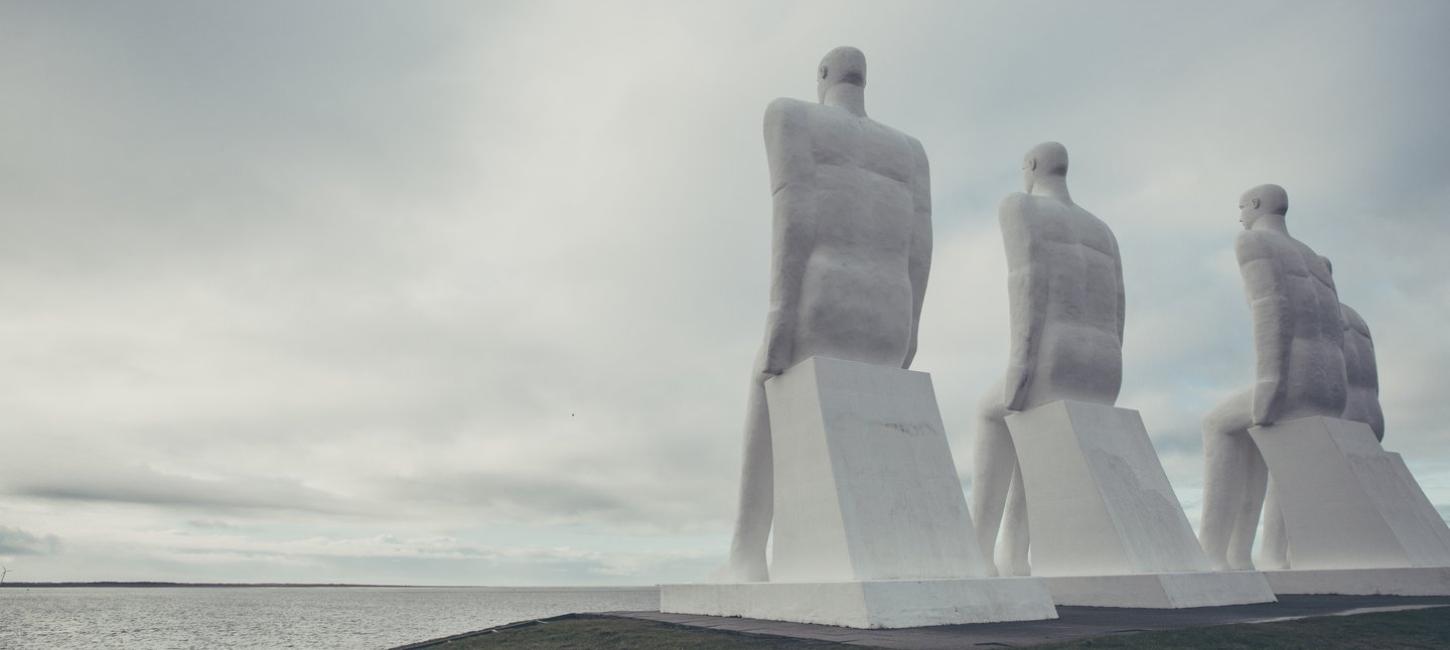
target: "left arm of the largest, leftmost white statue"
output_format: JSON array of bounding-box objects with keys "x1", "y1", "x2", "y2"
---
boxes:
[{"x1": 763, "y1": 99, "x2": 815, "y2": 374}]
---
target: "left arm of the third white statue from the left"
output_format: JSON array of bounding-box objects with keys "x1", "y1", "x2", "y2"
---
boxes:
[{"x1": 1234, "y1": 231, "x2": 1293, "y2": 425}]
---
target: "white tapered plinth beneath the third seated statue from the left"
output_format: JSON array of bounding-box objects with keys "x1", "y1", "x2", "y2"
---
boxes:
[{"x1": 1248, "y1": 416, "x2": 1450, "y2": 568}]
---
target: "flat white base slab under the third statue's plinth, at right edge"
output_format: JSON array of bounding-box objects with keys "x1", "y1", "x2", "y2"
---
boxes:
[{"x1": 1263, "y1": 566, "x2": 1450, "y2": 596}]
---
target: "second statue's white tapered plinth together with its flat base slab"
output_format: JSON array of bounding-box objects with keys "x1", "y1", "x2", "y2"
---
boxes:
[{"x1": 1006, "y1": 400, "x2": 1275, "y2": 608}]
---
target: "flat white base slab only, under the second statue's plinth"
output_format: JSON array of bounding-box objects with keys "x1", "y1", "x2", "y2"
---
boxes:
[{"x1": 1043, "y1": 572, "x2": 1276, "y2": 609}]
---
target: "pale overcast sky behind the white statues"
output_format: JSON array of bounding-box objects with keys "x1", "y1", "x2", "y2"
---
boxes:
[{"x1": 0, "y1": 0, "x2": 1450, "y2": 585}]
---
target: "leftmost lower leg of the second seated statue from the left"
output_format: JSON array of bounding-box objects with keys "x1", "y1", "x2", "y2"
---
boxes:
[{"x1": 972, "y1": 384, "x2": 1016, "y2": 576}]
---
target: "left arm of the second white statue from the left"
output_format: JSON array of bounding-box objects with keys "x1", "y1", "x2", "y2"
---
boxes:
[{"x1": 998, "y1": 194, "x2": 1047, "y2": 411}]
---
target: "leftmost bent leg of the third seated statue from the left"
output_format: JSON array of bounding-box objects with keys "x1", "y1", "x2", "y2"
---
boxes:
[{"x1": 1198, "y1": 392, "x2": 1253, "y2": 570}]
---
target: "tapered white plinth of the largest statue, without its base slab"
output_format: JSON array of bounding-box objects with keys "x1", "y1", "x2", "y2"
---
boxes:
[{"x1": 766, "y1": 357, "x2": 985, "y2": 582}]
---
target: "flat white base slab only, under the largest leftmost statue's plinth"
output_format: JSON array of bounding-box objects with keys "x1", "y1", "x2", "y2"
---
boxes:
[{"x1": 660, "y1": 577, "x2": 1057, "y2": 628}]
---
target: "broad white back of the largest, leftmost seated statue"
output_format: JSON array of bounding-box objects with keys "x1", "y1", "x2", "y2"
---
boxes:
[{"x1": 766, "y1": 99, "x2": 925, "y2": 367}]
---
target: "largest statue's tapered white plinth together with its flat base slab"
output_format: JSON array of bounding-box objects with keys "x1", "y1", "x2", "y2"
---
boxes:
[{"x1": 660, "y1": 357, "x2": 1057, "y2": 628}]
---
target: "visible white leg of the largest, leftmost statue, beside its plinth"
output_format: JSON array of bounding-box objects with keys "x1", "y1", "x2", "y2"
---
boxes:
[{"x1": 724, "y1": 373, "x2": 776, "y2": 582}]
